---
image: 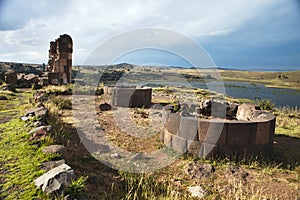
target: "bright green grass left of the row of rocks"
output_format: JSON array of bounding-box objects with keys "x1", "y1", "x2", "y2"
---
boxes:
[{"x1": 0, "y1": 119, "x2": 51, "y2": 199}]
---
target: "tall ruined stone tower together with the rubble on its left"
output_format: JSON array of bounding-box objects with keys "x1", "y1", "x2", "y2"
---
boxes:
[{"x1": 0, "y1": 34, "x2": 73, "y2": 89}]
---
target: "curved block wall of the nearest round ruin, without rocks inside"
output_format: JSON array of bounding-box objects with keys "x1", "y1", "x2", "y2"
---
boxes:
[{"x1": 161, "y1": 109, "x2": 276, "y2": 158}]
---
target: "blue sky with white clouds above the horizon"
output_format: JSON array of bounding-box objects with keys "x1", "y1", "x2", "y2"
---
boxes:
[{"x1": 0, "y1": 0, "x2": 300, "y2": 70}]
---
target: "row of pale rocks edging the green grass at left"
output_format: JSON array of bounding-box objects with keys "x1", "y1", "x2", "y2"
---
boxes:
[{"x1": 21, "y1": 100, "x2": 76, "y2": 195}]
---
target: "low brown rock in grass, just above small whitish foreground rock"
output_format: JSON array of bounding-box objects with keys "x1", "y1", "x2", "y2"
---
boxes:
[{"x1": 185, "y1": 161, "x2": 216, "y2": 179}]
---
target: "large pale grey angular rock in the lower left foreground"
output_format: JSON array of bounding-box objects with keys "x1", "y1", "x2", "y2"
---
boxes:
[{"x1": 34, "y1": 164, "x2": 75, "y2": 195}]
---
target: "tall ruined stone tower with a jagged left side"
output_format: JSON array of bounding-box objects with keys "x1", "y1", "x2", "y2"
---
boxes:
[{"x1": 47, "y1": 34, "x2": 73, "y2": 85}]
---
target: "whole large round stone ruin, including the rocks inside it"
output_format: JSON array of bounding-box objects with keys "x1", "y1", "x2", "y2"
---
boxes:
[{"x1": 161, "y1": 101, "x2": 276, "y2": 158}]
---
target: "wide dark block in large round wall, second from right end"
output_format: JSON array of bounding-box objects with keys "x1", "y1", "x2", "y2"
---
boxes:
[{"x1": 227, "y1": 123, "x2": 256, "y2": 146}]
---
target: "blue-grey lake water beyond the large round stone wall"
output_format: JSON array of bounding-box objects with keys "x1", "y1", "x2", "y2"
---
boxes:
[{"x1": 191, "y1": 81, "x2": 300, "y2": 108}]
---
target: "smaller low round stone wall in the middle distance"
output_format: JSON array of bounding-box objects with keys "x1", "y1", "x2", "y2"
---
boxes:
[{"x1": 104, "y1": 87, "x2": 152, "y2": 108}]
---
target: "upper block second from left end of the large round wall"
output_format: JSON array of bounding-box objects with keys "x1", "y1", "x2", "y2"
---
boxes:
[{"x1": 178, "y1": 117, "x2": 199, "y2": 141}]
